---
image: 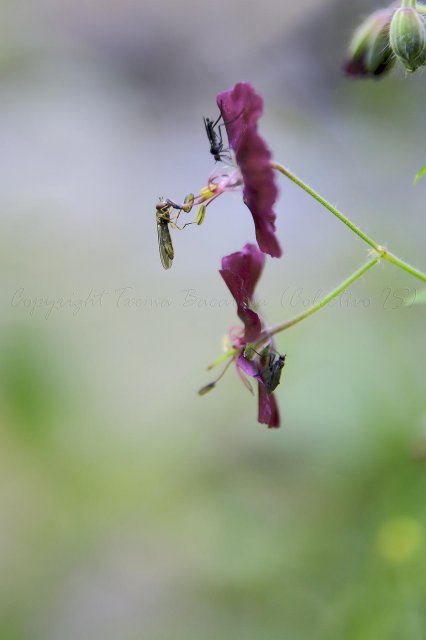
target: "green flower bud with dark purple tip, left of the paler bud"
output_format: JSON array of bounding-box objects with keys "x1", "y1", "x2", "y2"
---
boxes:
[{"x1": 344, "y1": 7, "x2": 395, "y2": 76}]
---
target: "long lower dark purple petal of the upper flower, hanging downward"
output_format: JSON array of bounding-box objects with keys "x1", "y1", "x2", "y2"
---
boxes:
[{"x1": 236, "y1": 128, "x2": 282, "y2": 258}]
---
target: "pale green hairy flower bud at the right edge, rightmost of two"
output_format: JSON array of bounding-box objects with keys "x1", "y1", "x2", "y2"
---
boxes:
[{"x1": 389, "y1": 7, "x2": 426, "y2": 71}]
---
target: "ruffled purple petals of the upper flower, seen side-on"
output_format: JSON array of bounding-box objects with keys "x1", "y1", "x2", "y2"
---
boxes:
[{"x1": 217, "y1": 82, "x2": 282, "y2": 258}]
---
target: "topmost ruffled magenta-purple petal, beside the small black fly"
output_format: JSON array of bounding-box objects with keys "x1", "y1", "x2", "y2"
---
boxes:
[{"x1": 216, "y1": 82, "x2": 263, "y2": 152}]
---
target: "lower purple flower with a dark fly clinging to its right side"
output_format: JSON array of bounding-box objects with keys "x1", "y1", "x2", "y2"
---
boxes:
[{"x1": 201, "y1": 244, "x2": 282, "y2": 428}]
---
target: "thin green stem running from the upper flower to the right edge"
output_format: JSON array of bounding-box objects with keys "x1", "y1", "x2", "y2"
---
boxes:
[{"x1": 272, "y1": 162, "x2": 426, "y2": 282}]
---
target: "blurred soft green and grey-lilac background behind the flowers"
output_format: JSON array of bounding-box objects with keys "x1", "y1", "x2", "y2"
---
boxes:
[{"x1": 0, "y1": 0, "x2": 426, "y2": 640}]
